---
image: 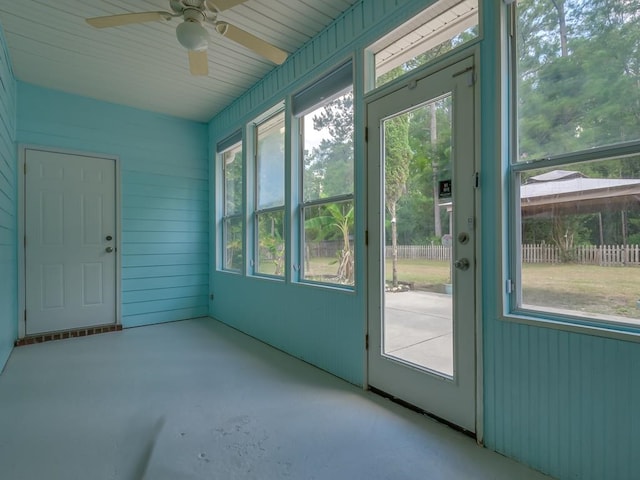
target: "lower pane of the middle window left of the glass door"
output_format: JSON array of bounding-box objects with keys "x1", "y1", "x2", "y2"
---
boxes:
[{"x1": 256, "y1": 210, "x2": 285, "y2": 276}]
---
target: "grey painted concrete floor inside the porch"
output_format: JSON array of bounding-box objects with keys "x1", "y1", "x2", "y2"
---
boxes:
[{"x1": 0, "y1": 319, "x2": 548, "y2": 480}]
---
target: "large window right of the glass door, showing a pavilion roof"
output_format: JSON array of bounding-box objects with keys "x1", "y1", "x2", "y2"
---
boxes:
[{"x1": 510, "y1": 0, "x2": 640, "y2": 326}]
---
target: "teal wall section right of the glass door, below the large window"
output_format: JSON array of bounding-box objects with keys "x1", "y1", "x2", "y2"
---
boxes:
[{"x1": 481, "y1": 1, "x2": 640, "y2": 480}]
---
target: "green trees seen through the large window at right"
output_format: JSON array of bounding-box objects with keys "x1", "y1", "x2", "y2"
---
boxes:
[{"x1": 517, "y1": 0, "x2": 640, "y2": 261}]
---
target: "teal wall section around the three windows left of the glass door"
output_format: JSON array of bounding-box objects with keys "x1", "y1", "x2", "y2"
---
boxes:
[{"x1": 209, "y1": 0, "x2": 426, "y2": 385}]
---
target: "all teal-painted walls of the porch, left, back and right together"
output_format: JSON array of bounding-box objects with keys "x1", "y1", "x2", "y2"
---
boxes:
[{"x1": 0, "y1": 0, "x2": 640, "y2": 479}]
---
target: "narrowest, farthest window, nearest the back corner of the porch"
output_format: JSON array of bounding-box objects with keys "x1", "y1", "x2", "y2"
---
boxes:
[{"x1": 217, "y1": 132, "x2": 244, "y2": 272}]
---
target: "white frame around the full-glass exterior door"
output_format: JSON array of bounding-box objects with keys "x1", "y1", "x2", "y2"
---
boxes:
[{"x1": 363, "y1": 51, "x2": 482, "y2": 445}]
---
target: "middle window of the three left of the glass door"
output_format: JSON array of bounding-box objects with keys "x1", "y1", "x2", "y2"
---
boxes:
[{"x1": 253, "y1": 111, "x2": 285, "y2": 277}]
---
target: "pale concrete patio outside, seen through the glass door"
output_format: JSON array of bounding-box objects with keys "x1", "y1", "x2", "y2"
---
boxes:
[{"x1": 384, "y1": 290, "x2": 453, "y2": 376}]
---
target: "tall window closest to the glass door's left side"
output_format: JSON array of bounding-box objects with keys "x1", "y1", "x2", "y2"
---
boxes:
[{"x1": 293, "y1": 62, "x2": 355, "y2": 286}]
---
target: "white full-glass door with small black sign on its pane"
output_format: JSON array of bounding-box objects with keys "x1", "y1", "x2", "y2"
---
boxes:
[{"x1": 367, "y1": 58, "x2": 476, "y2": 432}]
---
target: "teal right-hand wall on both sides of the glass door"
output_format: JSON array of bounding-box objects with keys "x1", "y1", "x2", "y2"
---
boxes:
[{"x1": 210, "y1": 0, "x2": 640, "y2": 480}]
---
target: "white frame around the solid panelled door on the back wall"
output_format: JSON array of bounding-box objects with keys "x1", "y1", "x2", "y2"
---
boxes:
[{"x1": 17, "y1": 144, "x2": 122, "y2": 339}]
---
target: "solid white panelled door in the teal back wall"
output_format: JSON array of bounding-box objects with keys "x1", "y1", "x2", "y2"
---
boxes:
[{"x1": 24, "y1": 149, "x2": 116, "y2": 335}]
